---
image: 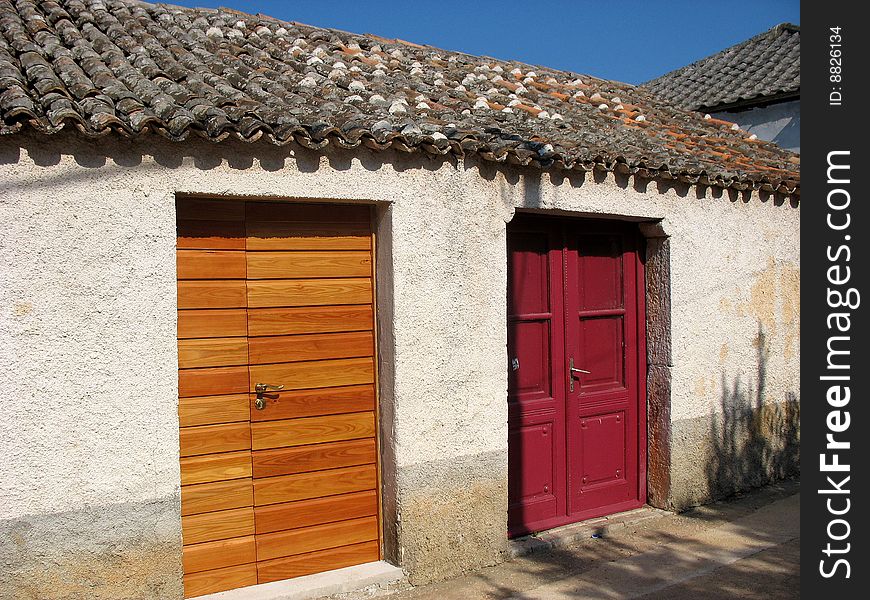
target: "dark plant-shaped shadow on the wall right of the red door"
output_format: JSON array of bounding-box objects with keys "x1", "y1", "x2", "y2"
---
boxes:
[{"x1": 706, "y1": 323, "x2": 800, "y2": 498}]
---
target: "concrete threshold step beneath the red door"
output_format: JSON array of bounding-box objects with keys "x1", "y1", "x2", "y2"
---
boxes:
[{"x1": 508, "y1": 506, "x2": 671, "y2": 558}]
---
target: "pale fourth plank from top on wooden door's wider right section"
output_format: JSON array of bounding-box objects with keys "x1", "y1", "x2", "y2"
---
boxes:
[{"x1": 245, "y1": 278, "x2": 372, "y2": 308}]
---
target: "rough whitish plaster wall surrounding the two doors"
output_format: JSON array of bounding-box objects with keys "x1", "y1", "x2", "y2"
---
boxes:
[{"x1": 0, "y1": 129, "x2": 799, "y2": 597}]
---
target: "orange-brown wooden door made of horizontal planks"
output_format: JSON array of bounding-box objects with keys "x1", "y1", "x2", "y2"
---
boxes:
[{"x1": 177, "y1": 199, "x2": 381, "y2": 597}]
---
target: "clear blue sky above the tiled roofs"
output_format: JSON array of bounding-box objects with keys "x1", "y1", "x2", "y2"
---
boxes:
[{"x1": 169, "y1": 0, "x2": 800, "y2": 83}]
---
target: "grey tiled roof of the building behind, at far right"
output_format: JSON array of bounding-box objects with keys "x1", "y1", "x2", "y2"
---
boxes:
[{"x1": 642, "y1": 23, "x2": 801, "y2": 111}]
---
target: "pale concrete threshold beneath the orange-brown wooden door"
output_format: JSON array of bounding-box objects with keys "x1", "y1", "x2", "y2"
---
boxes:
[{"x1": 197, "y1": 560, "x2": 405, "y2": 600}]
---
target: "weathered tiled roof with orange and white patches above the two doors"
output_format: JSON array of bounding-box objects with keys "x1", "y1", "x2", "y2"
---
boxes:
[{"x1": 0, "y1": 0, "x2": 799, "y2": 195}]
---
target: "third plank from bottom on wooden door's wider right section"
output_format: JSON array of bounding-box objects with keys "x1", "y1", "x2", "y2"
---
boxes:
[{"x1": 254, "y1": 490, "x2": 378, "y2": 534}]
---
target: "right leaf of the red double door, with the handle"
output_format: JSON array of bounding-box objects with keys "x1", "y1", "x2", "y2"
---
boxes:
[{"x1": 566, "y1": 224, "x2": 645, "y2": 518}]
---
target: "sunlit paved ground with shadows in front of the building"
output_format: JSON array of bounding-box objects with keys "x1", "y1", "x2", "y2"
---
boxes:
[{"x1": 372, "y1": 482, "x2": 800, "y2": 600}]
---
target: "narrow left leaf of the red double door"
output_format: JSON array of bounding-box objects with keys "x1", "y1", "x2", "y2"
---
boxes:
[{"x1": 508, "y1": 225, "x2": 565, "y2": 533}]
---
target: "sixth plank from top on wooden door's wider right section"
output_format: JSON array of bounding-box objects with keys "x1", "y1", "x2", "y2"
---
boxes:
[{"x1": 250, "y1": 331, "x2": 374, "y2": 364}]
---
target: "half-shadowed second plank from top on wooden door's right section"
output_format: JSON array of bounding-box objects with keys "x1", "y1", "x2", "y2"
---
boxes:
[{"x1": 247, "y1": 221, "x2": 372, "y2": 251}]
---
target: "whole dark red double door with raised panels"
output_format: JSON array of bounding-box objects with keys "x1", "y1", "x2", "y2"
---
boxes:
[{"x1": 508, "y1": 215, "x2": 646, "y2": 535}]
